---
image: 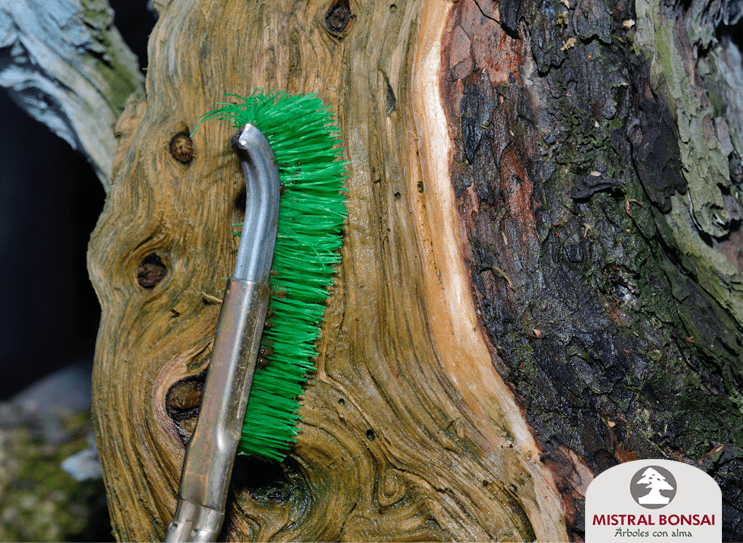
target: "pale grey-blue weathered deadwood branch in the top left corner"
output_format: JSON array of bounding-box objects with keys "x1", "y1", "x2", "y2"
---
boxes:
[{"x1": 0, "y1": 0, "x2": 143, "y2": 190}]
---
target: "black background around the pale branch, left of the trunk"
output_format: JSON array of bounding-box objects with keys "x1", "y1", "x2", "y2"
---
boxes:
[{"x1": 0, "y1": 0, "x2": 155, "y2": 400}]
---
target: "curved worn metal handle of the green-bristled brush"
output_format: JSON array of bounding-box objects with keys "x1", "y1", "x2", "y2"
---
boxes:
[{"x1": 165, "y1": 124, "x2": 279, "y2": 542}]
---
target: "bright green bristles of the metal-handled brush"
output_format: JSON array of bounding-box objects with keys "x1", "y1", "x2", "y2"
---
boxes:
[{"x1": 201, "y1": 91, "x2": 348, "y2": 461}]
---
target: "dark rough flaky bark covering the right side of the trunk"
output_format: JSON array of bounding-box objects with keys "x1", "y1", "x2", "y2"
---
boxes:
[{"x1": 442, "y1": 0, "x2": 743, "y2": 540}]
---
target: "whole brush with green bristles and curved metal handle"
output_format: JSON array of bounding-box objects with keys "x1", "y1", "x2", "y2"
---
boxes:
[{"x1": 166, "y1": 91, "x2": 347, "y2": 541}]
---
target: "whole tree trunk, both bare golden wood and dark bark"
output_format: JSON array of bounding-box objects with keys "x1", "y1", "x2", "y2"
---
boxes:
[{"x1": 89, "y1": 0, "x2": 743, "y2": 541}]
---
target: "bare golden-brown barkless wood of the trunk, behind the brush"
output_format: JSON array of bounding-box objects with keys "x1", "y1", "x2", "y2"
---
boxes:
[{"x1": 89, "y1": 0, "x2": 566, "y2": 541}]
